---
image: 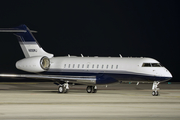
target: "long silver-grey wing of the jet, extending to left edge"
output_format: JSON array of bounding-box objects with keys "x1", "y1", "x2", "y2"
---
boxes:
[{"x1": 0, "y1": 74, "x2": 96, "y2": 84}]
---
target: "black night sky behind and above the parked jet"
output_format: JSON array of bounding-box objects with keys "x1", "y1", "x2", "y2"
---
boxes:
[{"x1": 0, "y1": 0, "x2": 180, "y2": 81}]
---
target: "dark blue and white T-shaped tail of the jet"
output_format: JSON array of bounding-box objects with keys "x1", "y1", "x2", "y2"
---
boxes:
[{"x1": 0, "y1": 25, "x2": 53, "y2": 58}]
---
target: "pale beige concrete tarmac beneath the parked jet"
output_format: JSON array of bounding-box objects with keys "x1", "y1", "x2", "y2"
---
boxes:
[{"x1": 0, "y1": 82, "x2": 180, "y2": 120}]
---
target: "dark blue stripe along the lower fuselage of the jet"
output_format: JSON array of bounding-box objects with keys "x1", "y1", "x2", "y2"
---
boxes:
[{"x1": 44, "y1": 71, "x2": 171, "y2": 84}]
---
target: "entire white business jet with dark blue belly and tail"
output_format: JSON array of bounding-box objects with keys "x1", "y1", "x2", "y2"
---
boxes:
[{"x1": 0, "y1": 25, "x2": 172, "y2": 96}]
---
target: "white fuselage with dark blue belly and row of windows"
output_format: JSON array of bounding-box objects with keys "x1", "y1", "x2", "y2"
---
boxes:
[{"x1": 46, "y1": 56, "x2": 172, "y2": 84}]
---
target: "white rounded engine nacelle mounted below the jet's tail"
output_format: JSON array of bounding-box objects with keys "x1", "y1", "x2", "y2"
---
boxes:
[{"x1": 16, "y1": 56, "x2": 50, "y2": 73}]
